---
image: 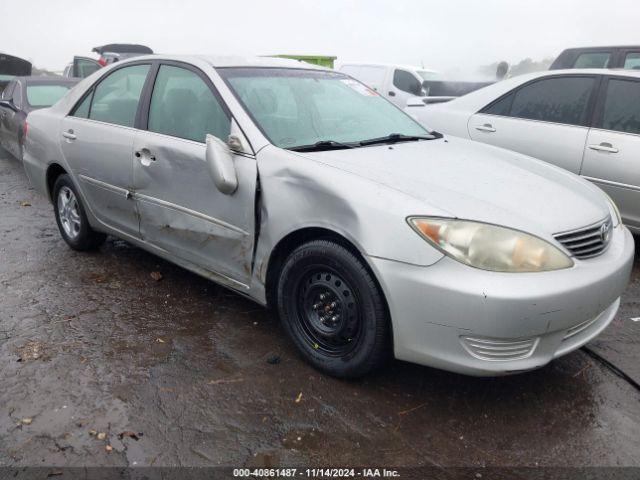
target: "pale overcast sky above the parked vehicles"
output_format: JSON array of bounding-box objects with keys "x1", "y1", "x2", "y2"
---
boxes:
[{"x1": 5, "y1": 0, "x2": 640, "y2": 71}]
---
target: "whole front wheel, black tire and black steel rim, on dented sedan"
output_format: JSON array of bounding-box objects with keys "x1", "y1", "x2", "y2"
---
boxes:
[{"x1": 277, "y1": 240, "x2": 390, "y2": 378}]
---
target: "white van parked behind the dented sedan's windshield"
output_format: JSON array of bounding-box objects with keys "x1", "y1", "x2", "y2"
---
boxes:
[{"x1": 339, "y1": 63, "x2": 442, "y2": 108}]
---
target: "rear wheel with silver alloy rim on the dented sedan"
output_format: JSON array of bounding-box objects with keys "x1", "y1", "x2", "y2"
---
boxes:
[{"x1": 53, "y1": 174, "x2": 107, "y2": 251}]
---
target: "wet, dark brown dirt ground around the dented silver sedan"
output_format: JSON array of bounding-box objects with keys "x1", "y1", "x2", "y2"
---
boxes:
[{"x1": 0, "y1": 152, "x2": 640, "y2": 467}]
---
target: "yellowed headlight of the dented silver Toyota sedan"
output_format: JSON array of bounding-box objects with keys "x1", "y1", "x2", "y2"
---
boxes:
[{"x1": 408, "y1": 217, "x2": 573, "y2": 272}]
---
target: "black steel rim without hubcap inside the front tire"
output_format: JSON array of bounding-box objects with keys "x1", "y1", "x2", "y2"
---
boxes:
[{"x1": 297, "y1": 268, "x2": 362, "y2": 356}]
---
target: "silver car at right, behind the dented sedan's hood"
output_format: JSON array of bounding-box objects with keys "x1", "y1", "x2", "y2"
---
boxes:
[{"x1": 407, "y1": 69, "x2": 640, "y2": 232}]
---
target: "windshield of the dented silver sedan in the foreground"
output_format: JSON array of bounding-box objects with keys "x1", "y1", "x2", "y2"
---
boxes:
[{"x1": 218, "y1": 68, "x2": 429, "y2": 149}]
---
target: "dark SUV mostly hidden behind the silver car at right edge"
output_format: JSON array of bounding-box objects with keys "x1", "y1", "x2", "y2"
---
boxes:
[{"x1": 549, "y1": 45, "x2": 640, "y2": 70}]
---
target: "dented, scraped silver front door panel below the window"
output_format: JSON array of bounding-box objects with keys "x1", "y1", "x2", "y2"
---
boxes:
[{"x1": 133, "y1": 131, "x2": 257, "y2": 285}]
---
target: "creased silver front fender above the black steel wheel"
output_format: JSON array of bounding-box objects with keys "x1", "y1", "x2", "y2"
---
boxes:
[{"x1": 254, "y1": 147, "x2": 446, "y2": 300}]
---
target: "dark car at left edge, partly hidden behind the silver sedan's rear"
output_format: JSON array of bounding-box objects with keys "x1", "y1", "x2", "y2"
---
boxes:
[{"x1": 0, "y1": 77, "x2": 77, "y2": 160}]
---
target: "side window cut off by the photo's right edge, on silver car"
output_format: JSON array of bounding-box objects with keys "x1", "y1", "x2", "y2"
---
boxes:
[{"x1": 602, "y1": 79, "x2": 640, "y2": 134}]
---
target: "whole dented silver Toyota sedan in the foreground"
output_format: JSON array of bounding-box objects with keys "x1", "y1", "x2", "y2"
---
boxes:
[{"x1": 24, "y1": 56, "x2": 634, "y2": 377}]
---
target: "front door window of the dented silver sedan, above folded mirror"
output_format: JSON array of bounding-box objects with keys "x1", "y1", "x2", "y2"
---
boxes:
[{"x1": 148, "y1": 65, "x2": 231, "y2": 143}]
